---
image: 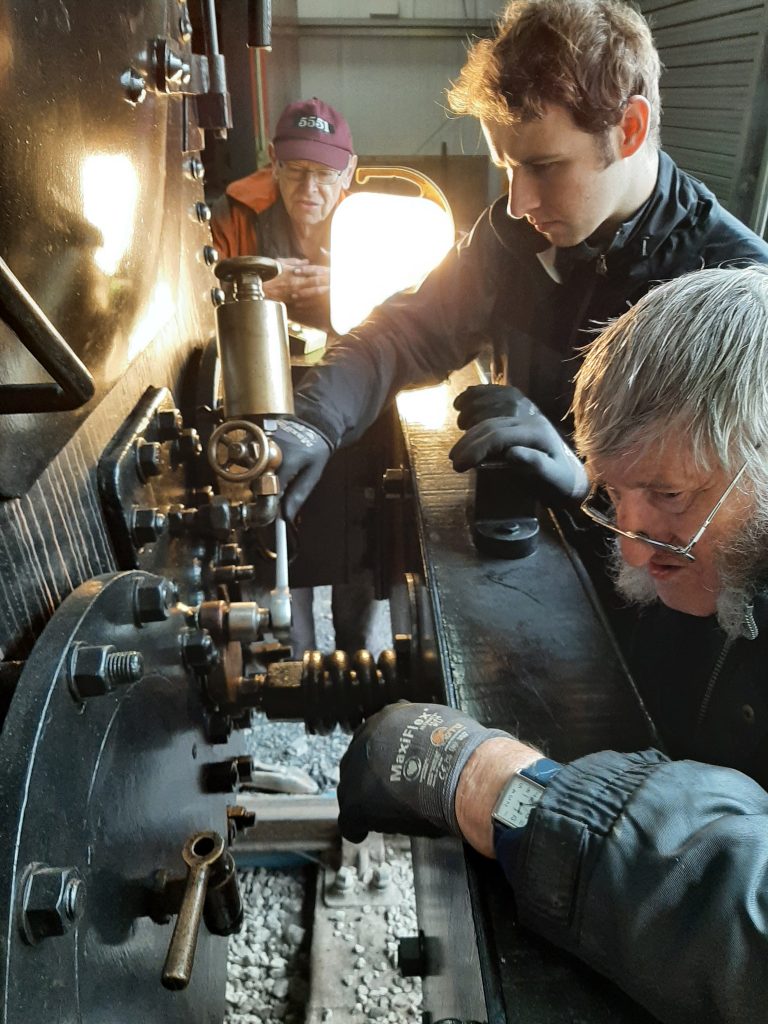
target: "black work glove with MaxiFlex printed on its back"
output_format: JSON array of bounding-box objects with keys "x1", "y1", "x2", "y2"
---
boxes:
[{"x1": 338, "y1": 700, "x2": 509, "y2": 843}]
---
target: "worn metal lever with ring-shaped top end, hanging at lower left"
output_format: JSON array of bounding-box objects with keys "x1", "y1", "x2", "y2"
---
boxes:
[{"x1": 163, "y1": 831, "x2": 225, "y2": 989}]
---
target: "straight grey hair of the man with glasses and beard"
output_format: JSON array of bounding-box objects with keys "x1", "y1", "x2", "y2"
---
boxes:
[{"x1": 571, "y1": 265, "x2": 768, "y2": 493}]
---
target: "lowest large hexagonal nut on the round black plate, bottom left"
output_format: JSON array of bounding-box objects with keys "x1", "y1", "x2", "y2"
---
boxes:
[{"x1": 20, "y1": 864, "x2": 85, "y2": 944}]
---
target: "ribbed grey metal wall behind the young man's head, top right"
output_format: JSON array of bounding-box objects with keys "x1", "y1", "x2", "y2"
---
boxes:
[{"x1": 639, "y1": 0, "x2": 767, "y2": 226}]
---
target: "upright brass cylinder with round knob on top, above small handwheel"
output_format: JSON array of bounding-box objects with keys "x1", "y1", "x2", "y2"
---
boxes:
[{"x1": 215, "y1": 256, "x2": 293, "y2": 419}]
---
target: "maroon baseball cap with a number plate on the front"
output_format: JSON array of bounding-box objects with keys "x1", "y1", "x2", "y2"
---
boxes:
[{"x1": 272, "y1": 96, "x2": 354, "y2": 171}]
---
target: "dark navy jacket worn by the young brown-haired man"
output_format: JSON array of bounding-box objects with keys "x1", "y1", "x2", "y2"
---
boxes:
[{"x1": 296, "y1": 153, "x2": 768, "y2": 447}]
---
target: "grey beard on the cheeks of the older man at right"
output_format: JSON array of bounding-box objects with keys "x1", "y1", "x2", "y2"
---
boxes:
[{"x1": 609, "y1": 532, "x2": 768, "y2": 640}]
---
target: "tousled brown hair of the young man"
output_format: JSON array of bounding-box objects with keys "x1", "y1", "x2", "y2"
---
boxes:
[{"x1": 446, "y1": 0, "x2": 662, "y2": 145}]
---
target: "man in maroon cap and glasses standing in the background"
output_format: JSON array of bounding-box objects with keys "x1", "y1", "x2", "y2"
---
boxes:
[{"x1": 212, "y1": 96, "x2": 357, "y2": 330}]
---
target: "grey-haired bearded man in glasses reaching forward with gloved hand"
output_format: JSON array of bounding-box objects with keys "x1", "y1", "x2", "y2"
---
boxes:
[{"x1": 339, "y1": 267, "x2": 768, "y2": 1024}]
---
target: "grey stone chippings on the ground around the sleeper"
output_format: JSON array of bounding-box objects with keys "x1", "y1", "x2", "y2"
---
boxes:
[{"x1": 224, "y1": 588, "x2": 422, "y2": 1024}]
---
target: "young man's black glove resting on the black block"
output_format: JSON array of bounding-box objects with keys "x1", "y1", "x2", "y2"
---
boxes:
[{"x1": 449, "y1": 384, "x2": 589, "y2": 505}]
